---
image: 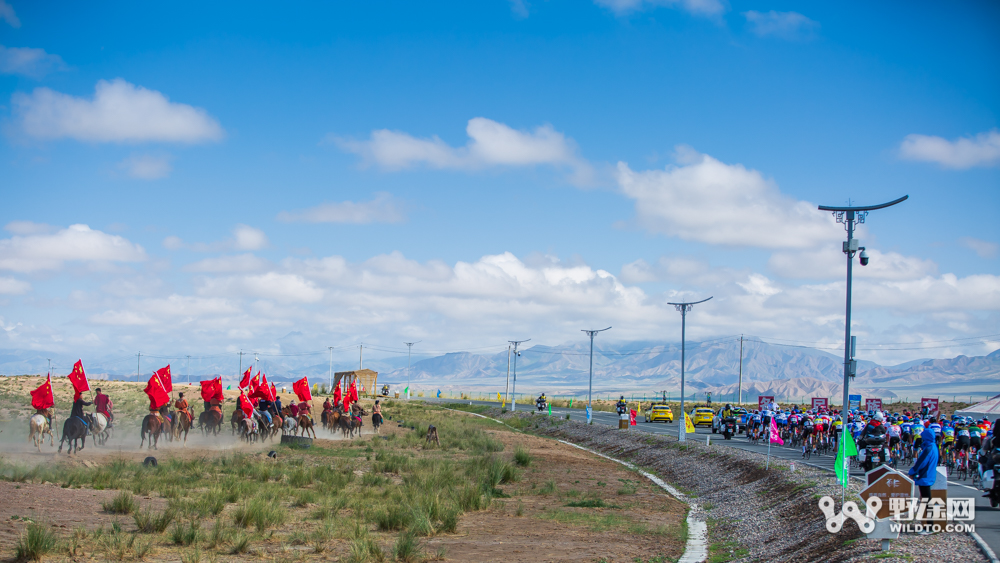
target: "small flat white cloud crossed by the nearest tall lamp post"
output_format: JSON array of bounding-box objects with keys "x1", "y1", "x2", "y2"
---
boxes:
[{"x1": 767, "y1": 244, "x2": 937, "y2": 280}]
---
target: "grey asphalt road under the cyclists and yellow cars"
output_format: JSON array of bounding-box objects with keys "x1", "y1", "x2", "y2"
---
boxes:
[{"x1": 426, "y1": 398, "x2": 1000, "y2": 555}]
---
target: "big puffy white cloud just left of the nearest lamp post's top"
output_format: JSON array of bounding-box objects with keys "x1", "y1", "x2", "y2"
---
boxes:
[{"x1": 618, "y1": 148, "x2": 840, "y2": 248}]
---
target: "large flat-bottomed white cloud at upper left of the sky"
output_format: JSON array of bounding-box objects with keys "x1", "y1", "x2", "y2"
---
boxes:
[{"x1": 11, "y1": 78, "x2": 223, "y2": 143}]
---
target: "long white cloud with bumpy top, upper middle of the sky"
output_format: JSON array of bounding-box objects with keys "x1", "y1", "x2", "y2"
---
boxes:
[{"x1": 335, "y1": 117, "x2": 592, "y2": 183}]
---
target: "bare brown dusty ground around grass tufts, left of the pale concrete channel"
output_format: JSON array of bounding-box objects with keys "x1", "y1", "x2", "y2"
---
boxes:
[{"x1": 0, "y1": 406, "x2": 686, "y2": 563}]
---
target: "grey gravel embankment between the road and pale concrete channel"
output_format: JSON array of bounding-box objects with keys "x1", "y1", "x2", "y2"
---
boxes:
[{"x1": 486, "y1": 409, "x2": 988, "y2": 563}]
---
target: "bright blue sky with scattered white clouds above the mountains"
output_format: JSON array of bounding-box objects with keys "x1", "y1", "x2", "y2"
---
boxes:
[{"x1": 0, "y1": 0, "x2": 1000, "y2": 368}]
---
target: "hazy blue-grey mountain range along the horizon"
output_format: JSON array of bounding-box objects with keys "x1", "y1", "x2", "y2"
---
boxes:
[{"x1": 0, "y1": 339, "x2": 1000, "y2": 403}]
